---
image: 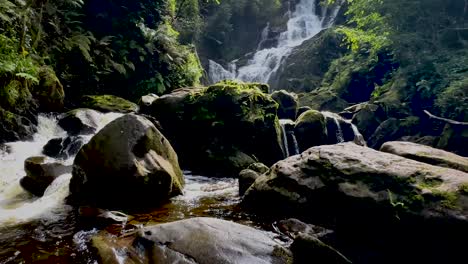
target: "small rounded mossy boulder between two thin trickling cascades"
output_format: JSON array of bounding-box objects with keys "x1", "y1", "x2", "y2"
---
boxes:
[{"x1": 294, "y1": 110, "x2": 328, "y2": 152}]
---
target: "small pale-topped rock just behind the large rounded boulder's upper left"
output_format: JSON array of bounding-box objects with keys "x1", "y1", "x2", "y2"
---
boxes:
[{"x1": 58, "y1": 108, "x2": 100, "y2": 136}]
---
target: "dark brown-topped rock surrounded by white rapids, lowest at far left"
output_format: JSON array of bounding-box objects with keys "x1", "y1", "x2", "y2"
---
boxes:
[{"x1": 20, "y1": 156, "x2": 72, "y2": 196}]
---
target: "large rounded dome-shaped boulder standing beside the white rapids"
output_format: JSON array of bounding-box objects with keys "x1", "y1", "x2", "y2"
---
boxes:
[{"x1": 70, "y1": 114, "x2": 184, "y2": 208}]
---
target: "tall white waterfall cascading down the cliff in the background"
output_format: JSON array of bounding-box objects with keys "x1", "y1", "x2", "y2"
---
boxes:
[{"x1": 209, "y1": 0, "x2": 340, "y2": 83}]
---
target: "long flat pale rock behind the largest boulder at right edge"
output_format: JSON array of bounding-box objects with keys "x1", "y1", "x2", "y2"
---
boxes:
[{"x1": 380, "y1": 141, "x2": 468, "y2": 172}]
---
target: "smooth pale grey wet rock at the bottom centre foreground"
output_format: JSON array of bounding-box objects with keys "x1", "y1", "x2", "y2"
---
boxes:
[{"x1": 93, "y1": 218, "x2": 292, "y2": 264}]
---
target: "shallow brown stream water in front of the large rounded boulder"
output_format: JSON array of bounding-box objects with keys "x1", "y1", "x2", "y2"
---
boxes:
[{"x1": 0, "y1": 172, "x2": 282, "y2": 263}]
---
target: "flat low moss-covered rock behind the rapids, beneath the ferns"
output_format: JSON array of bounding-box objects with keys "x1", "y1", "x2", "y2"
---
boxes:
[{"x1": 80, "y1": 94, "x2": 138, "y2": 113}]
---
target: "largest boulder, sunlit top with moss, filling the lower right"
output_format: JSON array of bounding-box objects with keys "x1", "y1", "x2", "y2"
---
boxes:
[{"x1": 242, "y1": 143, "x2": 468, "y2": 263}]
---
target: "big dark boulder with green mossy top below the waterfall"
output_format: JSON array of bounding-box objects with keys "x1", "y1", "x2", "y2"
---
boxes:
[{"x1": 150, "y1": 82, "x2": 283, "y2": 176}]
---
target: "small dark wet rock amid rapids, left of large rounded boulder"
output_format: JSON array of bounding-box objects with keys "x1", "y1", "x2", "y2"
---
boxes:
[{"x1": 42, "y1": 136, "x2": 84, "y2": 159}]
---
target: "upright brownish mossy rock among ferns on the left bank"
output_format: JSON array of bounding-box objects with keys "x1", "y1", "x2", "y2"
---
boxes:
[{"x1": 31, "y1": 66, "x2": 65, "y2": 112}]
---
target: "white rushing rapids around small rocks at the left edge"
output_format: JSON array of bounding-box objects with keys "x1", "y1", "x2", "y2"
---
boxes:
[{"x1": 0, "y1": 113, "x2": 121, "y2": 227}]
